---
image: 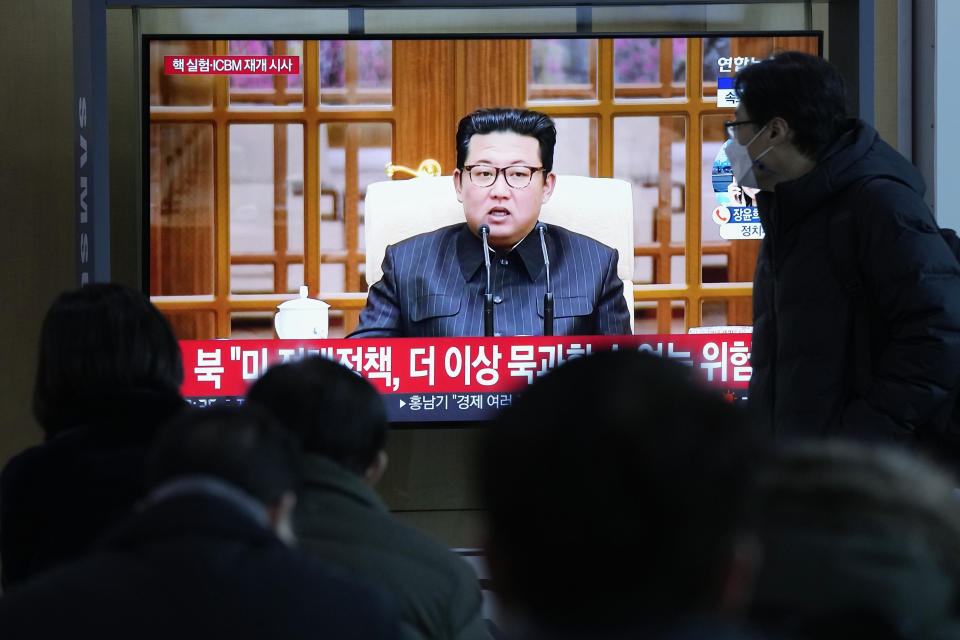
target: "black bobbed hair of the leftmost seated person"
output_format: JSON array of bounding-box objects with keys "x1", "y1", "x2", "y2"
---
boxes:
[{"x1": 33, "y1": 283, "x2": 183, "y2": 436}]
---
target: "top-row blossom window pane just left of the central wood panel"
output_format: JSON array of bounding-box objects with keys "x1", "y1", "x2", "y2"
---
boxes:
[{"x1": 319, "y1": 40, "x2": 393, "y2": 106}]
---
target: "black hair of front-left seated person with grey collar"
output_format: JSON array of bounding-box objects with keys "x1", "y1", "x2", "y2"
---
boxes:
[{"x1": 147, "y1": 406, "x2": 300, "y2": 505}]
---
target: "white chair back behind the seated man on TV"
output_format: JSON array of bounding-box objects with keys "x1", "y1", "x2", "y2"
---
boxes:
[{"x1": 364, "y1": 176, "x2": 633, "y2": 327}]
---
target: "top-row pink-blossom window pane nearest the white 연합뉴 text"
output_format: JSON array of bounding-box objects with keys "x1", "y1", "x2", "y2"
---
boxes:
[{"x1": 613, "y1": 38, "x2": 687, "y2": 101}]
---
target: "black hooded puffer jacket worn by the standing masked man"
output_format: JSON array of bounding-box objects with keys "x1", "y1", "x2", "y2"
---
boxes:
[{"x1": 749, "y1": 121, "x2": 960, "y2": 444}]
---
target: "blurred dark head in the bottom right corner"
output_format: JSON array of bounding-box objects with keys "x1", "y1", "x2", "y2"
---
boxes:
[{"x1": 752, "y1": 441, "x2": 960, "y2": 640}]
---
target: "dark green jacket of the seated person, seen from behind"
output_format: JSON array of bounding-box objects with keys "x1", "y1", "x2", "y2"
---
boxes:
[{"x1": 295, "y1": 454, "x2": 490, "y2": 640}]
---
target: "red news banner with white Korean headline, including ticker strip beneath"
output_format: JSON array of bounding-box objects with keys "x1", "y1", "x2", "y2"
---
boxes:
[{"x1": 180, "y1": 333, "x2": 752, "y2": 422}]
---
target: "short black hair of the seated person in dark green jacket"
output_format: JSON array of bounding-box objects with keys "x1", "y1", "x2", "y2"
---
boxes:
[{"x1": 247, "y1": 357, "x2": 388, "y2": 474}]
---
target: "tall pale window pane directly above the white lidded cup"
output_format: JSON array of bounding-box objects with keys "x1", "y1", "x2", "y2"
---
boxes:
[{"x1": 230, "y1": 124, "x2": 303, "y2": 293}]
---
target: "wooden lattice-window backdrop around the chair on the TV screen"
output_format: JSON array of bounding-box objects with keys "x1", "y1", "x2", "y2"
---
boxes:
[{"x1": 142, "y1": 31, "x2": 822, "y2": 420}]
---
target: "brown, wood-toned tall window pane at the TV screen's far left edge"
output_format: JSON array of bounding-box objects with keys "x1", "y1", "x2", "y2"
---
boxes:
[{"x1": 150, "y1": 123, "x2": 214, "y2": 296}]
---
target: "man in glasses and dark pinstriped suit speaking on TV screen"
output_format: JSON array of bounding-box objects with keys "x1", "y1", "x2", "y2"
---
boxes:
[{"x1": 350, "y1": 109, "x2": 631, "y2": 337}]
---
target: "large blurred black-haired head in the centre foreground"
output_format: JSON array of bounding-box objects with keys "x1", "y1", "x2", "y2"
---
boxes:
[{"x1": 480, "y1": 351, "x2": 759, "y2": 631}]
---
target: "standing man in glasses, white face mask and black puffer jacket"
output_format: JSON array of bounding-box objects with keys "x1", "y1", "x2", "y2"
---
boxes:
[{"x1": 727, "y1": 51, "x2": 960, "y2": 444}]
